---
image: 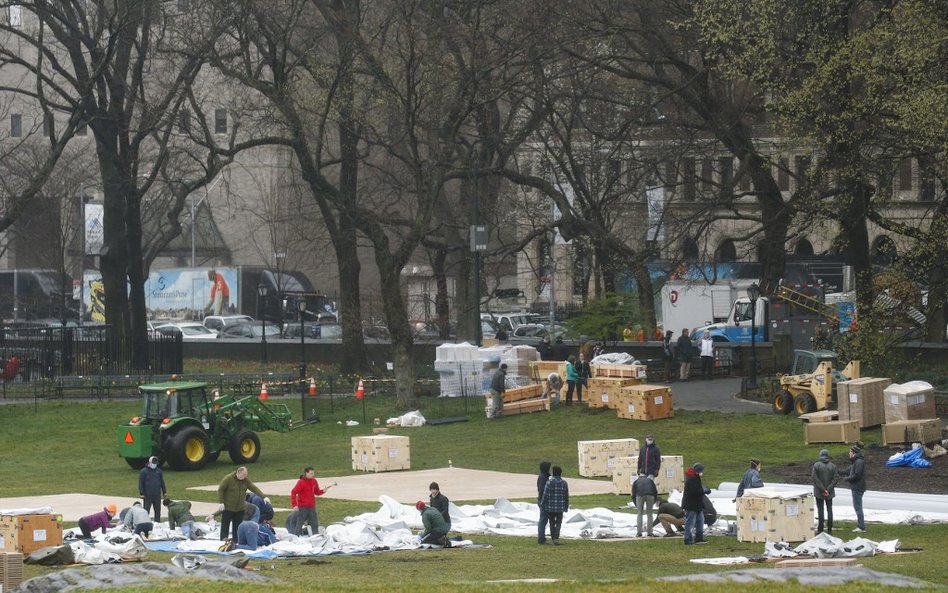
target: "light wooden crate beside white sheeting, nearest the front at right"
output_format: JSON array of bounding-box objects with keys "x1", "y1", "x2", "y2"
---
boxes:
[{"x1": 737, "y1": 493, "x2": 813, "y2": 543}]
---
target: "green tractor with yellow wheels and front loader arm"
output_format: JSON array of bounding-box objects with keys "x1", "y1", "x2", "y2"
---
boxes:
[{"x1": 116, "y1": 381, "x2": 296, "y2": 471}]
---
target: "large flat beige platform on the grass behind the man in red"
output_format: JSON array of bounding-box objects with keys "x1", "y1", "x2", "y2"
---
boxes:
[{"x1": 190, "y1": 467, "x2": 612, "y2": 504}]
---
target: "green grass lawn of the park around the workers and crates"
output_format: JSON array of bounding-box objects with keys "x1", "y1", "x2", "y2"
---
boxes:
[{"x1": 0, "y1": 388, "x2": 948, "y2": 593}]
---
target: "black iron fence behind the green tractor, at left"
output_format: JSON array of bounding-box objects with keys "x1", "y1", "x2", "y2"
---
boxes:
[{"x1": 0, "y1": 325, "x2": 184, "y2": 381}]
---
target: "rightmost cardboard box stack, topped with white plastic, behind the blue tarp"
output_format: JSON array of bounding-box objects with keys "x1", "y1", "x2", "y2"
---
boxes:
[{"x1": 882, "y1": 381, "x2": 941, "y2": 445}]
